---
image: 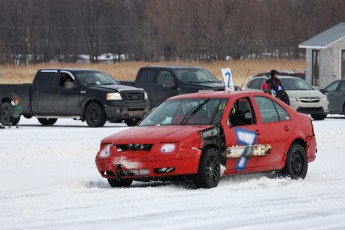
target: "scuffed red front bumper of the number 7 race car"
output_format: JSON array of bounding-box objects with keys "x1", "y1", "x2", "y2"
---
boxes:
[{"x1": 96, "y1": 149, "x2": 201, "y2": 179}]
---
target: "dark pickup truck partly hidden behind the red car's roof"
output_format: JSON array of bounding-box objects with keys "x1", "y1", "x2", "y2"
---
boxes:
[{"x1": 119, "y1": 66, "x2": 224, "y2": 108}]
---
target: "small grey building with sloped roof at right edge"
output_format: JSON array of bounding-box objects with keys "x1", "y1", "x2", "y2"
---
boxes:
[{"x1": 298, "y1": 22, "x2": 345, "y2": 88}]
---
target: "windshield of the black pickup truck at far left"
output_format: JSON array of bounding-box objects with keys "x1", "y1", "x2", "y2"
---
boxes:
[{"x1": 74, "y1": 71, "x2": 118, "y2": 86}]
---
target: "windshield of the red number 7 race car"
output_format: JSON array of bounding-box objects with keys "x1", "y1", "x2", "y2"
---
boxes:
[{"x1": 139, "y1": 98, "x2": 228, "y2": 126}]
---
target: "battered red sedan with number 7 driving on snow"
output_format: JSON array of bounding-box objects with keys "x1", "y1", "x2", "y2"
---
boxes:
[{"x1": 96, "y1": 91, "x2": 316, "y2": 188}]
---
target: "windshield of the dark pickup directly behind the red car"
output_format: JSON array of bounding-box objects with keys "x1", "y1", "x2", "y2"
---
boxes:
[{"x1": 173, "y1": 68, "x2": 220, "y2": 83}]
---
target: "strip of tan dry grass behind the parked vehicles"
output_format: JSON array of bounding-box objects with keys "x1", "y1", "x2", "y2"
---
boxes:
[{"x1": 0, "y1": 59, "x2": 305, "y2": 85}]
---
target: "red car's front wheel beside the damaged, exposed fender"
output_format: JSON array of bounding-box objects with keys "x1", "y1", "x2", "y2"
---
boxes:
[{"x1": 194, "y1": 148, "x2": 220, "y2": 188}]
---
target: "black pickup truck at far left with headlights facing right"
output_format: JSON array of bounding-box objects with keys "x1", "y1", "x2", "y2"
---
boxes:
[{"x1": 0, "y1": 68, "x2": 149, "y2": 127}]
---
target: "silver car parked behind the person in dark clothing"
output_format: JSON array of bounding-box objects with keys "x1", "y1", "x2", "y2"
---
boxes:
[{"x1": 245, "y1": 76, "x2": 329, "y2": 120}]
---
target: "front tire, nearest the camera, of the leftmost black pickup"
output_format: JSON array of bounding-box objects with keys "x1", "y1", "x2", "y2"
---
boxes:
[{"x1": 85, "y1": 103, "x2": 106, "y2": 127}]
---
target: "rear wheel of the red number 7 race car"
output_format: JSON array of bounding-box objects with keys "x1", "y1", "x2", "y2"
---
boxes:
[{"x1": 282, "y1": 143, "x2": 308, "y2": 179}]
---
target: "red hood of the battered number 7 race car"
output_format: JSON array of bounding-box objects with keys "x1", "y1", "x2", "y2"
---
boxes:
[{"x1": 102, "y1": 125, "x2": 212, "y2": 144}]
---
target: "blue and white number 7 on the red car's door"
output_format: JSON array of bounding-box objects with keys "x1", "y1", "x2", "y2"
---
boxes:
[{"x1": 234, "y1": 128, "x2": 257, "y2": 171}]
